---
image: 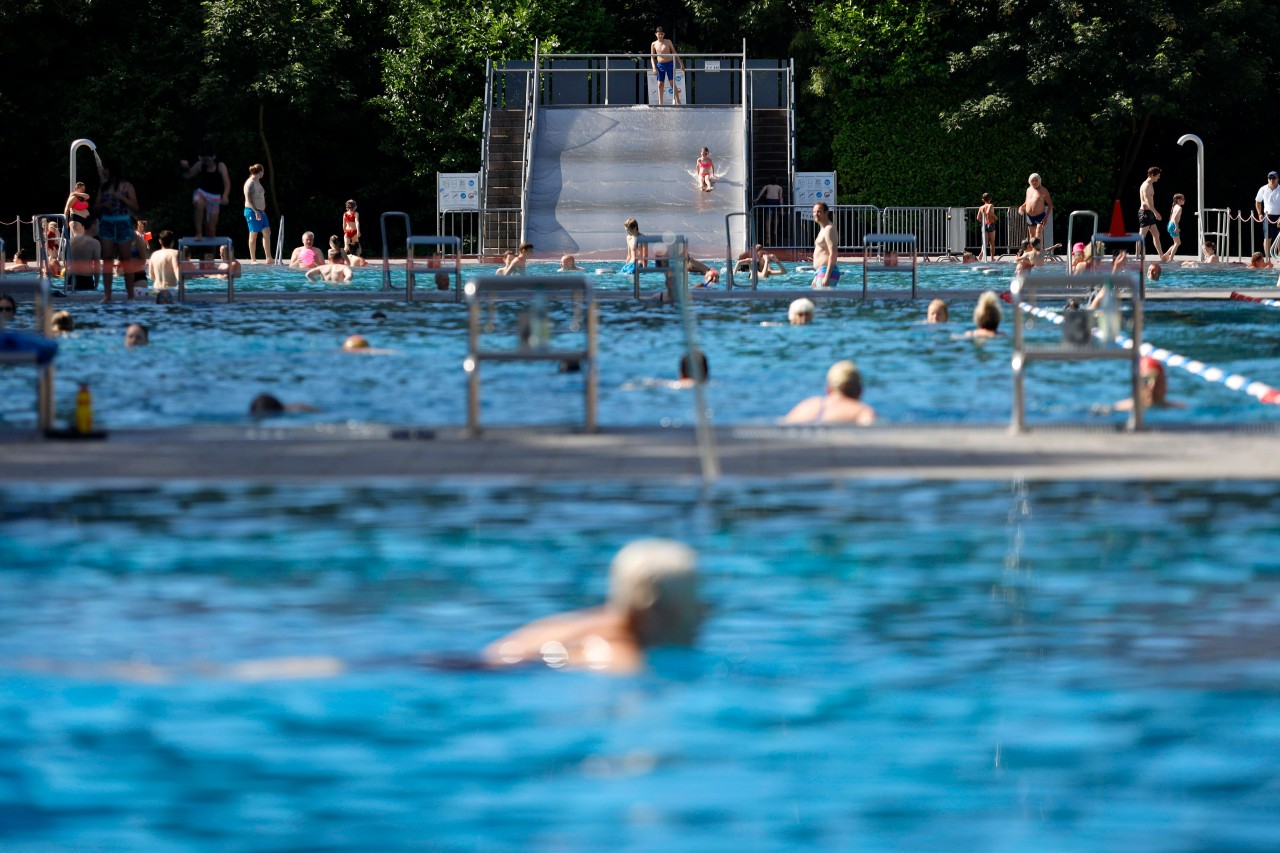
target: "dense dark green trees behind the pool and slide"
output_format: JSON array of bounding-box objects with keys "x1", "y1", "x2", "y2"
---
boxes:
[{"x1": 0, "y1": 0, "x2": 1280, "y2": 252}]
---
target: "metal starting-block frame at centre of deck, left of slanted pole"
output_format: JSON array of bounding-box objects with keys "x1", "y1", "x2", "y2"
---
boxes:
[{"x1": 462, "y1": 275, "x2": 599, "y2": 438}]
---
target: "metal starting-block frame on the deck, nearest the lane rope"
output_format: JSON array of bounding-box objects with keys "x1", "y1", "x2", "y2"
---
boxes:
[{"x1": 1009, "y1": 268, "x2": 1144, "y2": 434}]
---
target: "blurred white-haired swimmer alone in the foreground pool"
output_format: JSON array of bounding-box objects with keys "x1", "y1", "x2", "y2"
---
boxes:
[{"x1": 484, "y1": 539, "x2": 704, "y2": 672}]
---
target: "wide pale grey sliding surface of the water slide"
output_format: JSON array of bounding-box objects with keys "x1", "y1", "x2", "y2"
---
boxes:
[{"x1": 525, "y1": 106, "x2": 748, "y2": 260}]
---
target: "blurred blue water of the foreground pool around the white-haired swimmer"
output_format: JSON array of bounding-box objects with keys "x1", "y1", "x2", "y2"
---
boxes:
[{"x1": 0, "y1": 482, "x2": 1280, "y2": 852}]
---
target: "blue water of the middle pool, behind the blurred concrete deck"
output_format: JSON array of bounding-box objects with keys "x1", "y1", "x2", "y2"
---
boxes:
[{"x1": 0, "y1": 286, "x2": 1280, "y2": 429}]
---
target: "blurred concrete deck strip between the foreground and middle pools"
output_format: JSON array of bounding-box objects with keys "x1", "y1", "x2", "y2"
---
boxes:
[{"x1": 0, "y1": 425, "x2": 1280, "y2": 487}]
